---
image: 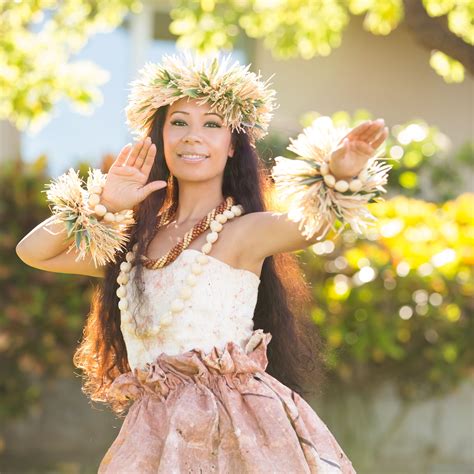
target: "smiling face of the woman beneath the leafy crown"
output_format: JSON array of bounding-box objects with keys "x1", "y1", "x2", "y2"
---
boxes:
[{"x1": 163, "y1": 98, "x2": 234, "y2": 181}]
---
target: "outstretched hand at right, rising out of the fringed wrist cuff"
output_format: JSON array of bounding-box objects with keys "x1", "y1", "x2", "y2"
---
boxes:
[{"x1": 329, "y1": 119, "x2": 388, "y2": 180}]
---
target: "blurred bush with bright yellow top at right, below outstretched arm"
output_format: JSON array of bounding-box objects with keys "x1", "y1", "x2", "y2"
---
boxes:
[{"x1": 301, "y1": 193, "x2": 474, "y2": 399}]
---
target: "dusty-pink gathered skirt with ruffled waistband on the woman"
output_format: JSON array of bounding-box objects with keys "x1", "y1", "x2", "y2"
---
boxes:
[{"x1": 99, "y1": 329, "x2": 355, "y2": 474}]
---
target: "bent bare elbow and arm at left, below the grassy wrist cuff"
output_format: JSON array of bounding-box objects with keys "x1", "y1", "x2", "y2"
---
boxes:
[{"x1": 16, "y1": 216, "x2": 104, "y2": 277}]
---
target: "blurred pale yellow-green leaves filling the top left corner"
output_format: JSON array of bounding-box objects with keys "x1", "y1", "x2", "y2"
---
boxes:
[{"x1": 0, "y1": 0, "x2": 141, "y2": 129}]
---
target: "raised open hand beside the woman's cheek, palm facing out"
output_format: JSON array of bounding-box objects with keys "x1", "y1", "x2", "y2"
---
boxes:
[{"x1": 101, "y1": 137, "x2": 167, "y2": 212}]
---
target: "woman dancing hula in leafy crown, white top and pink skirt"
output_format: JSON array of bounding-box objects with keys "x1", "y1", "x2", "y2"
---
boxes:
[{"x1": 17, "y1": 53, "x2": 387, "y2": 473}]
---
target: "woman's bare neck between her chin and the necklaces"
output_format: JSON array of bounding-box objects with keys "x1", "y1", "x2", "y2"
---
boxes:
[{"x1": 175, "y1": 182, "x2": 224, "y2": 225}]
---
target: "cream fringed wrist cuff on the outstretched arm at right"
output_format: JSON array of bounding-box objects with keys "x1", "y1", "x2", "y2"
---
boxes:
[{"x1": 272, "y1": 116, "x2": 392, "y2": 240}]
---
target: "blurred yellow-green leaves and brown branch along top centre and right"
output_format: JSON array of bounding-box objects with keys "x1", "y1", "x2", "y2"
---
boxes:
[{"x1": 170, "y1": 0, "x2": 474, "y2": 82}]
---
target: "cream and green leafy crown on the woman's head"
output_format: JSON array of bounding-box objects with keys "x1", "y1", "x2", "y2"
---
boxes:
[{"x1": 125, "y1": 53, "x2": 276, "y2": 143}]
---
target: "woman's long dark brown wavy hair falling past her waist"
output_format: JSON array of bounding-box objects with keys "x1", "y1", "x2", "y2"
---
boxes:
[{"x1": 73, "y1": 107, "x2": 324, "y2": 413}]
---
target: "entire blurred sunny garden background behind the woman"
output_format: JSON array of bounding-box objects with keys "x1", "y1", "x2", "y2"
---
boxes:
[{"x1": 0, "y1": 0, "x2": 474, "y2": 474}]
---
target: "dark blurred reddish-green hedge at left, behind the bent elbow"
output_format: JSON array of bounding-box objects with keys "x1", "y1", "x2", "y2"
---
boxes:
[{"x1": 0, "y1": 157, "x2": 92, "y2": 420}]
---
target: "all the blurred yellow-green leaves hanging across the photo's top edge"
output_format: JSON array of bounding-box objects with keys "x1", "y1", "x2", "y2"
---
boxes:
[{"x1": 0, "y1": 0, "x2": 474, "y2": 135}]
